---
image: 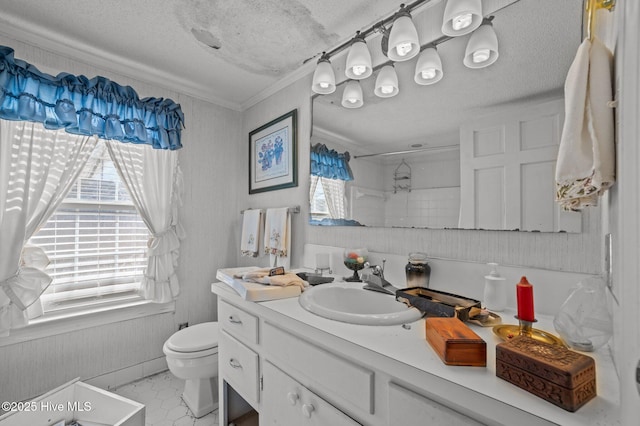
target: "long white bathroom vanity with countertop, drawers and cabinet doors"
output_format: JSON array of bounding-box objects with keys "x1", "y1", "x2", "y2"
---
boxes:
[{"x1": 211, "y1": 283, "x2": 620, "y2": 426}]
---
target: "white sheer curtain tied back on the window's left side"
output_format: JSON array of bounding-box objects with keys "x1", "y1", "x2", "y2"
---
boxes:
[{"x1": 0, "y1": 120, "x2": 98, "y2": 336}]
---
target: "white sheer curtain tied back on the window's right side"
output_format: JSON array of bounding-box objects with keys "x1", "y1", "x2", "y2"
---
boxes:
[{"x1": 107, "y1": 142, "x2": 184, "y2": 303}]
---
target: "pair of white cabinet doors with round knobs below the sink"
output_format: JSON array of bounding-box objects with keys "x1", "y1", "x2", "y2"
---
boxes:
[{"x1": 260, "y1": 362, "x2": 360, "y2": 426}]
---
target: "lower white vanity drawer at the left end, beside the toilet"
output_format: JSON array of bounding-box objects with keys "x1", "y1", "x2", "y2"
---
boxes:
[{"x1": 218, "y1": 331, "x2": 260, "y2": 407}]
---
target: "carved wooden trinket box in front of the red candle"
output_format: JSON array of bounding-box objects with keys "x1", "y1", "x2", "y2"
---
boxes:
[{"x1": 496, "y1": 336, "x2": 596, "y2": 412}]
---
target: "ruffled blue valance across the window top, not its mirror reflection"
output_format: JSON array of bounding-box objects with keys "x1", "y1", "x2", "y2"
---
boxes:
[{"x1": 0, "y1": 46, "x2": 184, "y2": 150}]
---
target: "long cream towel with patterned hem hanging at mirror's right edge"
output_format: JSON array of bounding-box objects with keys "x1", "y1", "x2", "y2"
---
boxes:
[{"x1": 556, "y1": 37, "x2": 615, "y2": 211}]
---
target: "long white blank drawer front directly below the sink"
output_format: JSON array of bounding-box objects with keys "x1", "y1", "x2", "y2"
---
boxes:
[{"x1": 262, "y1": 323, "x2": 374, "y2": 414}]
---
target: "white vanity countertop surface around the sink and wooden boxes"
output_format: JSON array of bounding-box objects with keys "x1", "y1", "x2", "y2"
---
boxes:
[{"x1": 212, "y1": 283, "x2": 620, "y2": 426}]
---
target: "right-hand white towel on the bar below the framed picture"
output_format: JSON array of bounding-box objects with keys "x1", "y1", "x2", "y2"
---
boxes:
[{"x1": 264, "y1": 207, "x2": 291, "y2": 269}]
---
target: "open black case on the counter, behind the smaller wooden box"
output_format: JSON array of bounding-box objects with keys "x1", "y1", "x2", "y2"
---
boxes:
[{"x1": 396, "y1": 287, "x2": 482, "y2": 321}]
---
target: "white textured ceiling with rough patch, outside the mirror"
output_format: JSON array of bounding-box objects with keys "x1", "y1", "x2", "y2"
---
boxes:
[{"x1": 0, "y1": 0, "x2": 410, "y2": 109}]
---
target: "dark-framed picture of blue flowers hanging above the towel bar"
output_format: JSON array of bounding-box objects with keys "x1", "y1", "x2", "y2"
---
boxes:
[{"x1": 249, "y1": 109, "x2": 298, "y2": 194}]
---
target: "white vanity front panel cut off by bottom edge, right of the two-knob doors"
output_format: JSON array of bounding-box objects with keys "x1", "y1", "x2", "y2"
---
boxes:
[{"x1": 387, "y1": 383, "x2": 482, "y2": 426}]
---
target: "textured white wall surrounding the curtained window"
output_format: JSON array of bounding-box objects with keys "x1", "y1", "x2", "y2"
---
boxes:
[{"x1": 0, "y1": 37, "x2": 247, "y2": 401}]
